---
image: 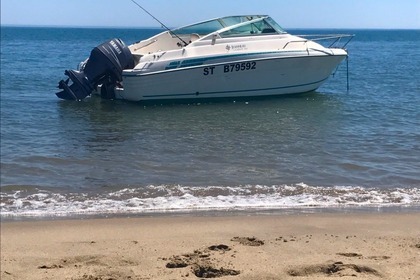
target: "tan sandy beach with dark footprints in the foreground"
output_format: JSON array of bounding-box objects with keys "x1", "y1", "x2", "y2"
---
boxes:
[{"x1": 0, "y1": 213, "x2": 420, "y2": 280}]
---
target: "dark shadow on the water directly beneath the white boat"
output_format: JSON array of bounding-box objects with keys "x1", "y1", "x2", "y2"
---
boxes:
[{"x1": 57, "y1": 89, "x2": 346, "y2": 117}]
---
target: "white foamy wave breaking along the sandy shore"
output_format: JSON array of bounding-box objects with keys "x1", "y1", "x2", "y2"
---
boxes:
[{"x1": 0, "y1": 183, "x2": 420, "y2": 217}]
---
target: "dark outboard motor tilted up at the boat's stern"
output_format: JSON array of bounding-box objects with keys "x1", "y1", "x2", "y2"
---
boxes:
[{"x1": 56, "y1": 39, "x2": 134, "y2": 100}]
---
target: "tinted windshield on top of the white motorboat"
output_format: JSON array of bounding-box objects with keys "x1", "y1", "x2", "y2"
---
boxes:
[{"x1": 173, "y1": 15, "x2": 276, "y2": 36}]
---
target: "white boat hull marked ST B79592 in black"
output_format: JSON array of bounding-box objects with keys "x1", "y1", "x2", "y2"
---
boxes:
[{"x1": 116, "y1": 50, "x2": 347, "y2": 101}]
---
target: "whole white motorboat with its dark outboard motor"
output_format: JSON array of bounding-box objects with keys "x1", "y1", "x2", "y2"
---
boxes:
[{"x1": 56, "y1": 15, "x2": 353, "y2": 101}]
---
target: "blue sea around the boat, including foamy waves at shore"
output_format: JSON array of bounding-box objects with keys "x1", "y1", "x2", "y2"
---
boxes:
[{"x1": 0, "y1": 26, "x2": 420, "y2": 221}]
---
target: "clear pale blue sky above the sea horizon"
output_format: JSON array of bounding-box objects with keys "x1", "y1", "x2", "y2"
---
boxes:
[{"x1": 1, "y1": 0, "x2": 420, "y2": 29}]
